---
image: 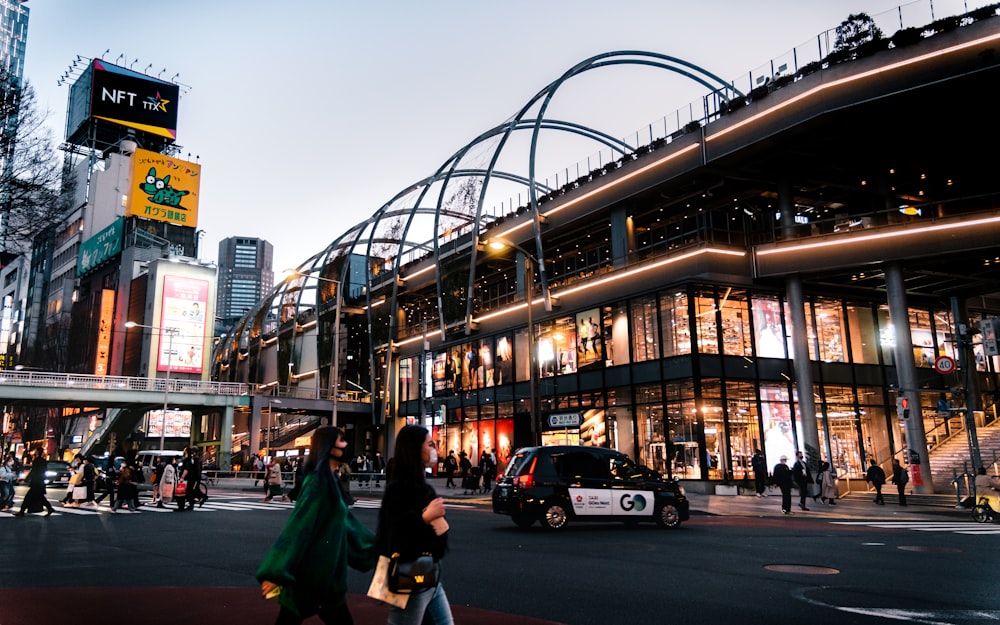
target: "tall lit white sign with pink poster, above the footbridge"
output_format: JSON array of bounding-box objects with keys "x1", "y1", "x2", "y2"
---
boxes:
[{"x1": 156, "y1": 275, "x2": 208, "y2": 373}]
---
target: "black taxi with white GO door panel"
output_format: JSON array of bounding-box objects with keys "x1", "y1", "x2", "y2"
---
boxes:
[{"x1": 493, "y1": 445, "x2": 689, "y2": 530}]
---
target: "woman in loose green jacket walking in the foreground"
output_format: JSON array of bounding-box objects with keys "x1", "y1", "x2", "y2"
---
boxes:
[{"x1": 257, "y1": 425, "x2": 377, "y2": 625}]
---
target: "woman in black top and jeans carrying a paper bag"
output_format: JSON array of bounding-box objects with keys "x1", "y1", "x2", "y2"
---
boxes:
[{"x1": 376, "y1": 425, "x2": 454, "y2": 625}]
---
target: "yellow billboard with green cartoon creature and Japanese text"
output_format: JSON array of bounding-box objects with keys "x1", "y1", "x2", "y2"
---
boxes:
[{"x1": 125, "y1": 148, "x2": 201, "y2": 228}]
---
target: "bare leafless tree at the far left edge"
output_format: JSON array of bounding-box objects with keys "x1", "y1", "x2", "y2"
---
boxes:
[{"x1": 0, "y1": 74, "x2": 73, "y2": 254}]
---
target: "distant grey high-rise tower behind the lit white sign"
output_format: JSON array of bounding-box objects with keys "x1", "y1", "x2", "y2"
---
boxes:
[{"x1": 215, "y1": 237, "x2": 274, "y2": 334}]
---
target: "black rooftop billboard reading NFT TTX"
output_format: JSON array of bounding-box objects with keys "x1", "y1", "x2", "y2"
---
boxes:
[{"x1": 66, "y1": 59, "x2": 180, "y2": 140}]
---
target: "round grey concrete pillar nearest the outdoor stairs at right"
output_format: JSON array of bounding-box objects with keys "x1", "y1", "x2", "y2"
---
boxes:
[{"x1": 878, "y1": 262, "x2": 934, "y2": 493}]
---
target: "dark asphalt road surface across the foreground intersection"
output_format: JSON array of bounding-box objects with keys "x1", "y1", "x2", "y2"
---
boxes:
[{"x1": 0, "y1": 488, "x2": 1000, "y2": 625}]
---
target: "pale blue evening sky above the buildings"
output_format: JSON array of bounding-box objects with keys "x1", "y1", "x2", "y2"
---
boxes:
[{"x1": 24, "y1": 0, "x2": 916, "y2": 273}]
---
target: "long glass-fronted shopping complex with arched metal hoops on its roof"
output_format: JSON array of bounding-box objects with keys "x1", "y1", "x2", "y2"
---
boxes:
[{"x1": 212, "y1": 3, "x2": 1000, "y2": 492}]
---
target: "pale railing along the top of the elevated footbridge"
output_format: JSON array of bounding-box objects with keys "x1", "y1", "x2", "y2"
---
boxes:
[{"x1": 0, "y1": 369, "x2": 251, "y2": 395}]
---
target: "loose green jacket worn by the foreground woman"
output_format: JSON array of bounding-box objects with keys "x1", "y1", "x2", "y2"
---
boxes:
[{"x1": 257, "y1": 473, "x2": 378, "y2": 618}]
